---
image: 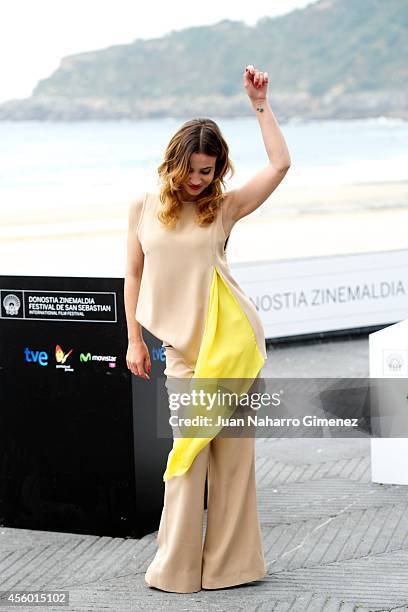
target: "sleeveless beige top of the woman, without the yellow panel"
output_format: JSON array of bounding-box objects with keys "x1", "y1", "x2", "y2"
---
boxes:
[{"x1": 135, "y1": 193, "x2": 266, "y2": 369}]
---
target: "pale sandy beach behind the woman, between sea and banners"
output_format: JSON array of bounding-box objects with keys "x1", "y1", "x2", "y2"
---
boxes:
[{"x1": 0, "y1": 182, "x2": 408, "y2": 276}]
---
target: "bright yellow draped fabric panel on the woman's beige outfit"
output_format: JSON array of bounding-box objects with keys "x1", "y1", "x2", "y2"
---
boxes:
[{"x1": 163, "y1": 266, "x2": 265, "y2": 481}]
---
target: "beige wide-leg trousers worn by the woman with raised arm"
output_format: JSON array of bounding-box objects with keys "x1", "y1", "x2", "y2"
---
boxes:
[{"x1": 145, "y1": 346, "x2": 267, "y2": 593}]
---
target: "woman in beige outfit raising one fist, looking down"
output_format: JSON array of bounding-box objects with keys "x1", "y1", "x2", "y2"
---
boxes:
[{"x1": 125, "y1": 65, "x2": 290, "y2": 593}]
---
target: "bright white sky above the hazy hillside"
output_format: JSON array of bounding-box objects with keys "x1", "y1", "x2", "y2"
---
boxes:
[{"x1": 0, "y1": 0, "x2": 316, "y2": 102}]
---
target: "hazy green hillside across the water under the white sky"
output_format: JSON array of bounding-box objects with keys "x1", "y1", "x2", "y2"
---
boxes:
[{"x1": 0, "y1": 0, "x2": 408, "y2": 118}]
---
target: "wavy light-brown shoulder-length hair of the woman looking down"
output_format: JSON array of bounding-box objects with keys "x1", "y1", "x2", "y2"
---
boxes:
[{"x1": 157, "y1": 117, "x2": 235, "y2": 228}]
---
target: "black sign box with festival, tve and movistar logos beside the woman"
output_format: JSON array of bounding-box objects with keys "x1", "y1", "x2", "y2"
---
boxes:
[{"x1": 0, "y1": 276, "x2": 171, "y2": 537}]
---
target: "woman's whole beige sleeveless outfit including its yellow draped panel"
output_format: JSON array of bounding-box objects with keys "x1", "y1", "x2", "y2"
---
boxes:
[{"x1": 135, "y1": 193, "x2": 266, "y2": 593}]
